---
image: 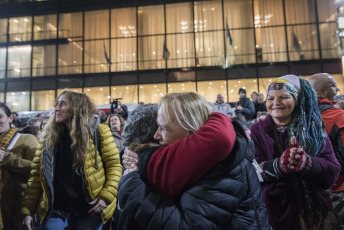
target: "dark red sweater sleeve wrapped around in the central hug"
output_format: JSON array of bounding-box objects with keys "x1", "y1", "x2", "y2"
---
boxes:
[{"x1": 147, "y1": 113, "x2": 236, "y2": 197}]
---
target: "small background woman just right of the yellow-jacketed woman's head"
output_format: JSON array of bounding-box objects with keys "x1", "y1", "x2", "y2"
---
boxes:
[{"x1": 106, "y1": 113, "x2": 125, "y2": 152}]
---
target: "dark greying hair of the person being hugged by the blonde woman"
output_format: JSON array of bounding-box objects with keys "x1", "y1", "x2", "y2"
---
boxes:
[{"x1": 122, "y1": 104, "x2": 158, "y2": 146}]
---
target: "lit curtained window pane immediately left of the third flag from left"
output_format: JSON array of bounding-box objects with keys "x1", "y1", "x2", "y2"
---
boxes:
[{"x1": 195, "y1": 31, "x2": 225, "y2": 66}]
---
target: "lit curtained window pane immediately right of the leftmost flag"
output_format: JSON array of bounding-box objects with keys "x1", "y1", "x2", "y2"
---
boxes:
[{"x1": 111, "y1": 38, "x2": 137, "y2": 72}]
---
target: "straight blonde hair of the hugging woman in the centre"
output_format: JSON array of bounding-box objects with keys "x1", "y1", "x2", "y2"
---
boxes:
[{"x1": 159, "y1": 92, "x2": 211, "y2": 133}]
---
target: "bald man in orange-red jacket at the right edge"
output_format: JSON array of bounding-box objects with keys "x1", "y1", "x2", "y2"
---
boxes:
[{"x1": 308, "y1": 73, "x2": 344, "y2": 229}]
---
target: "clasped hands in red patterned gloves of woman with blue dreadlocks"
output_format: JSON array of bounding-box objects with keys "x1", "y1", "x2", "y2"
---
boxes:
[{"x1": 278, "y1": 136, "x2": 311, "y2": 174}]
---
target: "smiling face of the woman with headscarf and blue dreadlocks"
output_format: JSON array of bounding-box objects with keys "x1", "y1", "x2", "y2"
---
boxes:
[{"x1": 266, "y1": 90, "x2": 295, "y2": 124}]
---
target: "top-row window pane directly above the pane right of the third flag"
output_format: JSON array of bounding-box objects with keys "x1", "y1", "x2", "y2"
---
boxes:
[{"x1": 223, "y1": 0, "x2": 253, "y2": 29}]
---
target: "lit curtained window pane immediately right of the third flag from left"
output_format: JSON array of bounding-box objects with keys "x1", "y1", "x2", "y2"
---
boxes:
[{"x1": 225, "y1": 29, "x2": 256, "y2": 66}]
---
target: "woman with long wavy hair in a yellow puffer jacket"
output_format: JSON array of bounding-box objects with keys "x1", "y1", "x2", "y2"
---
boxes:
[{"x1": 22, "y1": 91, "x2": 122, "y2": 229}]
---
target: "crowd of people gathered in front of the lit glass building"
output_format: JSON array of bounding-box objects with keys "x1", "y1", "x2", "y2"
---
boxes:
[{"x1": 0, "y1": 73, "x2": 344, "y2": 230}]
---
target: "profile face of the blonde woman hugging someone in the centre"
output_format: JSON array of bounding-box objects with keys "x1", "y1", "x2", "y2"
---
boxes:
[{"x1": 154, "y1": 110, "x2": 190, "y2": 145}]
